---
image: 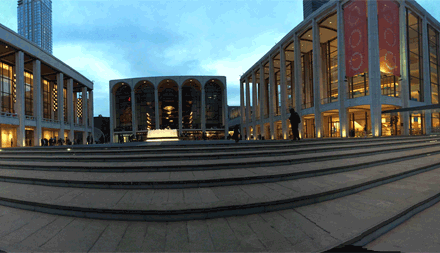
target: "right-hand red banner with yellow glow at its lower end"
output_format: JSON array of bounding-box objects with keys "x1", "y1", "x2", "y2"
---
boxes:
[{"x1": 377, "y1": 0, "x2": 400, "y2": 76}]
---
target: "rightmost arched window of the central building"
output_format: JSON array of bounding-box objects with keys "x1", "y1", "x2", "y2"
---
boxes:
[{"x1": 205, "y1": 81, "x2": 224, "y2": 129}]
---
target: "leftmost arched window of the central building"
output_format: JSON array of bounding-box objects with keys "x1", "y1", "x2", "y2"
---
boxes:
[{"x1": 115, "y1": 85, "x2": 132, "y2": 131}]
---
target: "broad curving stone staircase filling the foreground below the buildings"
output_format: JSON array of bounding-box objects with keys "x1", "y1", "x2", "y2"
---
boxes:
[{"x1": 0, "y1": 136, "x2": 440, "y2": 251}]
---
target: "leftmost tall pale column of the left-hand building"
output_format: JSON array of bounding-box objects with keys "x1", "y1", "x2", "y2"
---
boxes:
[{"x1": 13, "y1": 51, "x2": 26, "y2": 147}]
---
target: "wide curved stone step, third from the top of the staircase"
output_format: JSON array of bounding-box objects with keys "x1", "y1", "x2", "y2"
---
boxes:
[{"x1": 0, "y1": 142, "x2": 440, "y2": 172}]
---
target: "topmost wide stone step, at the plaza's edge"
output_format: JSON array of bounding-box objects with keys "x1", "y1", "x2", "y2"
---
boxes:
[{"x1": 0, "y1": 135, "x2": 439, "y2": 157}]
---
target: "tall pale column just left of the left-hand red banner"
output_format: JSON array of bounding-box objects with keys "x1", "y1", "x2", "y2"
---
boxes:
[{"x1": 337, "y1": 2, "x2": 349, "y2": 138}]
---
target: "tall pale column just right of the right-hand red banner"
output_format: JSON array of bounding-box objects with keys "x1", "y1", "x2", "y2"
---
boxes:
[{"x1": 399, "y1": 1, "x2": 410, "y2": 135}]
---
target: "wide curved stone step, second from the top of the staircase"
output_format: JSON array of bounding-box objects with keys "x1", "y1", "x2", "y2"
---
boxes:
[{"x1": 0, "y1": 138, "x2": 440, "y2": 162}]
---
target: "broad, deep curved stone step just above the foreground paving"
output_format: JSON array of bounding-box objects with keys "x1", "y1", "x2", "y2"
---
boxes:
[{"x1": 0, "y1": 152, "x2": 440, "y2": 221}]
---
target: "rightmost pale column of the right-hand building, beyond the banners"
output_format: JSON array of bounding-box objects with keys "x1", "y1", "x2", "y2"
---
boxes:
[{"x1": 422, "y1": 16, "x2": 432, "y2": 134}]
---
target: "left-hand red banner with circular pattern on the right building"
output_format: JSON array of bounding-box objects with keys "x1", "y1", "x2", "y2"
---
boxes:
[{"x1": 344, "y1": 0, "x2": 368, "y2": 77}]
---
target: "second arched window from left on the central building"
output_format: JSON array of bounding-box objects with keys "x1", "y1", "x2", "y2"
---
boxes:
[{"x1": 134, "y1": 82, "x2": 156, "y2": 131}]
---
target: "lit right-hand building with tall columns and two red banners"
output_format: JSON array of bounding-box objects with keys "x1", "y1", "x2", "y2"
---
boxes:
[{"x1": 240, "y1": 0, "x2": 440, "y2": 139}]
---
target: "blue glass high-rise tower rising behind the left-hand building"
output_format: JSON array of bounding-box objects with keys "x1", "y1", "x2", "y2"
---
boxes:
[{"x1": 17, "y1": 0, "x2": 52, "y2": 54}]
